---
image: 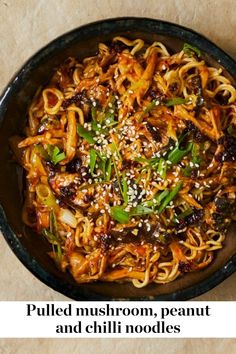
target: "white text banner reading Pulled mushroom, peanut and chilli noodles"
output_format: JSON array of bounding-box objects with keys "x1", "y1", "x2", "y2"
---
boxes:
[{"x1": 0, "y1": 301, "x2": 236, "y2": 338}]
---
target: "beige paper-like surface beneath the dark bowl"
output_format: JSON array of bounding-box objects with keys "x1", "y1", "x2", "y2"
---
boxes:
[{"x1": 0, "y1": 0, "x2": 236, "y2": 354}]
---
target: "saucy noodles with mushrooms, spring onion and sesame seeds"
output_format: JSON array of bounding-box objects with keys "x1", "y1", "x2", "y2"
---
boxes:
[{"x1": 14, "y1": 36, "x2": 236, "y2": 288}]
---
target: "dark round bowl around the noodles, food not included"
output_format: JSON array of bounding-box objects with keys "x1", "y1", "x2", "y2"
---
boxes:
[{"x1": 0, "y1": 18, "x2": 236, "y2": 300}]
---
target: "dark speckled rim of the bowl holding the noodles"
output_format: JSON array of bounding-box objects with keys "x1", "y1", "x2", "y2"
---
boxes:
[{"x1": 0, "y1": 17, "x2": 236, "y2": 301}]
